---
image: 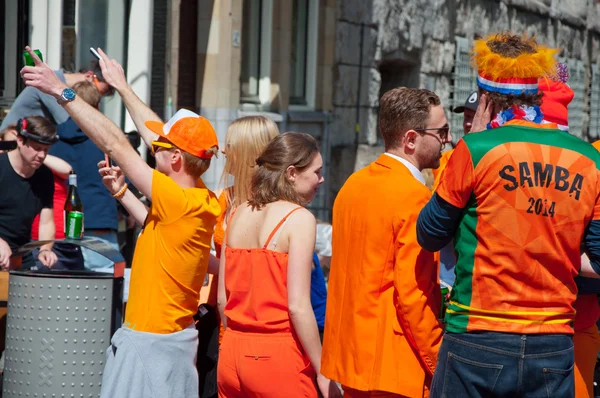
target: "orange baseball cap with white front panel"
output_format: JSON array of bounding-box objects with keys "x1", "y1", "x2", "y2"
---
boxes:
[{"x1": 145, "y1": 109, "x2": 219, "y2": 159}]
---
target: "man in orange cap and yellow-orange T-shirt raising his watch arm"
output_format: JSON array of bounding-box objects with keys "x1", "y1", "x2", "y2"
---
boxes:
[{"x1": 21, "y1": 47, "x2": 220, "y2": 398}]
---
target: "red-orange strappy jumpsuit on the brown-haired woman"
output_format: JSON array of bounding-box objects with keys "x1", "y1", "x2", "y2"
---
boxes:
[{"x1": 217, "y1": 207, "x2": 317, "y2": 398}]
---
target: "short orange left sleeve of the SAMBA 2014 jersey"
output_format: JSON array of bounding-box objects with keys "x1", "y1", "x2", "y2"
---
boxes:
[{"x1": 436, "y1": 140, "x2": 475, "y2": 209}]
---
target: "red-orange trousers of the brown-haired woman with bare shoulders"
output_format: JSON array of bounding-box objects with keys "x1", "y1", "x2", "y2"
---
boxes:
[{"x1": 217, "y1": 329, "x2": 317, "y2": 398}]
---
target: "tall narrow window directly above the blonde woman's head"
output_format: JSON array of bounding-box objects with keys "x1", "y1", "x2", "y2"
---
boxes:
[{"x1": 240, "y1": 0, "x2": 273, "y2": 105}]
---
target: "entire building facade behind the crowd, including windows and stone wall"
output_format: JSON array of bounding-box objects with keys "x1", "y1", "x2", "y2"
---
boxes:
[{"x1": 0, "y1": 0, "x2": 600, "y2": 220}]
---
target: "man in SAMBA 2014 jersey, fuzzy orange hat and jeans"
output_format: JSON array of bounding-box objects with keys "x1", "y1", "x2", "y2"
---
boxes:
[{"x1": 417, "y1": 33, "x2": 600, "y2": 397}]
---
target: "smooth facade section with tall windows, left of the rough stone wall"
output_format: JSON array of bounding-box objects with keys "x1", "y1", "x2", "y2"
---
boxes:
[{"x1": 0, "y1": 0, "x2": 336, "y2": 219}]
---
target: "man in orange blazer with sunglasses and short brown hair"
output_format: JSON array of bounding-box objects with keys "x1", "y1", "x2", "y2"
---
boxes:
[{"x1": 321, "y1": 87, "x2": 451, "y2": 398}]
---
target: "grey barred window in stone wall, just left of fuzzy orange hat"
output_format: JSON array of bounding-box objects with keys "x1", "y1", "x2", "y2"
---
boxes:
[{"x1": 450, "y1": 37, "x2": 477, "y2": 143}]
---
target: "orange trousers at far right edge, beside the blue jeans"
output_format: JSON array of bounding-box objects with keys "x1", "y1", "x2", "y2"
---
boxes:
[{"x1": 573, "y1": 325, "x2": 600, "y2": 398}]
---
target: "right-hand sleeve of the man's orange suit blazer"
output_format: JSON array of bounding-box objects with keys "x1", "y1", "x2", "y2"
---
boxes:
[{"x1": 394, "y1": 192, "x2": 442, "y2": 375}]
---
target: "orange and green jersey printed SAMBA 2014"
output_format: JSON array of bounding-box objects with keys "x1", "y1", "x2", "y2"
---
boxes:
[{"x1": 437, "y1": 121, "x2": 600, "y2": 334}]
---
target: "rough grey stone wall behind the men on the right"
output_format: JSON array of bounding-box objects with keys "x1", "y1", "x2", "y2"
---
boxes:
[{"x1": 329, "y1": 0, "x2": 600, "y2": 210}]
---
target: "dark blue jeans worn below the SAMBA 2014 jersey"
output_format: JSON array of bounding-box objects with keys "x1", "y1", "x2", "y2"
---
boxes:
[{"x1": 431, "y1": 332, "x2": 575, "y2": 398}]
